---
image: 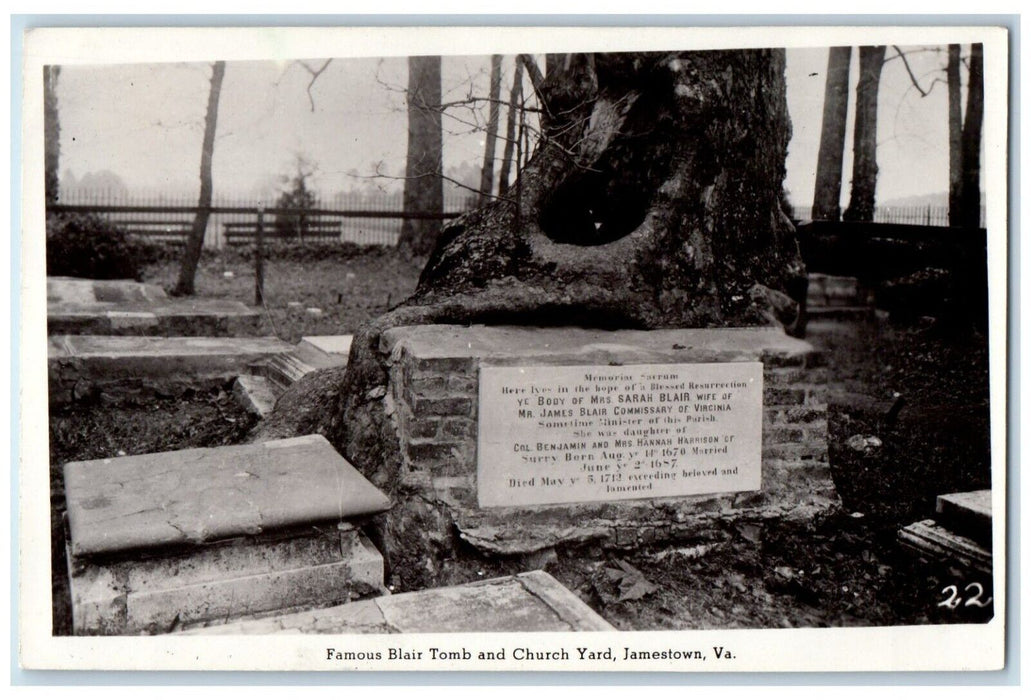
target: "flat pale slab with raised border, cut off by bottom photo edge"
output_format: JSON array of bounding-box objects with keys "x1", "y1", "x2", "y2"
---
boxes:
[{"x1": 184, "y1": 571, "x2": 614, "y2": 635}]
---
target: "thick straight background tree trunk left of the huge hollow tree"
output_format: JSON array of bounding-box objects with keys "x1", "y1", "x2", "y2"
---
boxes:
[{"x1": 398, "y1": 56, "x2": 444, "y2": 256}]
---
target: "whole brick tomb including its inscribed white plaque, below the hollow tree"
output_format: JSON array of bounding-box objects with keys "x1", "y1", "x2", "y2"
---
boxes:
[{"x1": 371, "y1": 326, "x2": 838, "y2": 555}]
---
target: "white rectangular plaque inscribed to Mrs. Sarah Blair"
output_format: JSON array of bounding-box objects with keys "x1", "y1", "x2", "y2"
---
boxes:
[{"x1": 476, "y1": 362, "x2": 763, "y2": 507}]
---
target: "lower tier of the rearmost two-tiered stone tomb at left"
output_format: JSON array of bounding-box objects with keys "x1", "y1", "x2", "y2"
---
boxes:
[{"x1": 46, "y1": 295, "x2": 261, "y2": 336}]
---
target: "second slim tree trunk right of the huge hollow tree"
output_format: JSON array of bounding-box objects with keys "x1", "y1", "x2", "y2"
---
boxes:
[{"x1": 843, "y1": 46, "x2": 887, "y2": 222}]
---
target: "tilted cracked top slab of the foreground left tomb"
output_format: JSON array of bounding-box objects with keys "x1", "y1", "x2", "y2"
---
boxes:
[{"x1": 64, "y1": 435, "x2": 390, "y2": 557}]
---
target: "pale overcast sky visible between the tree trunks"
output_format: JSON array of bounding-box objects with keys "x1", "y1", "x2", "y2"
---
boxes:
[{"x1": 58, "y1": 46, "x2": 973, "y2": 206}]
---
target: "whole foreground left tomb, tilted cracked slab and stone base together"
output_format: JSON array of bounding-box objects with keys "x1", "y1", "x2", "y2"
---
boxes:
[{"x1": 64, "y1": 435, "x2": 390, "y2": 634}]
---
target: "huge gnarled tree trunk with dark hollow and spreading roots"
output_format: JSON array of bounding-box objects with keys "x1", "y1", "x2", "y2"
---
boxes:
[{"x1": 255, "y1": 49, "x2": 805, "y2": 588}]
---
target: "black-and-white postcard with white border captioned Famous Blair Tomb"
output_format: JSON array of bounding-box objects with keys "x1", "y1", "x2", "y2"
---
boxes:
[{"x1": 20, "y1": 26, "x2": 1009, "y2": 671}]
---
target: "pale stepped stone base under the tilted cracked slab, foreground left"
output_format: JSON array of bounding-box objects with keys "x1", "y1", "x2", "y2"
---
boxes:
[{"x1": 69, "y1": 522, "x2": 384, "y2": 635}]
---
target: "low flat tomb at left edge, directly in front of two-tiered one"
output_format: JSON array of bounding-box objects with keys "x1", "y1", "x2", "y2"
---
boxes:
[{"x1": 47, "y1": 335, "x2": 294, "y2": 405}]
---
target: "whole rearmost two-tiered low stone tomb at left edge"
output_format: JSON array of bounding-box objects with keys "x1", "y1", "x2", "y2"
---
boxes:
[{"x1": 46, "y1": 277, "x2": 261, "y2": 336}]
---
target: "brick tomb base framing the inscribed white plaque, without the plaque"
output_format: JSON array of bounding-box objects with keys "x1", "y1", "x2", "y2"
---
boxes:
[{"x1": 380, "y1": 326, "x2": 837, "y2": 555}]
